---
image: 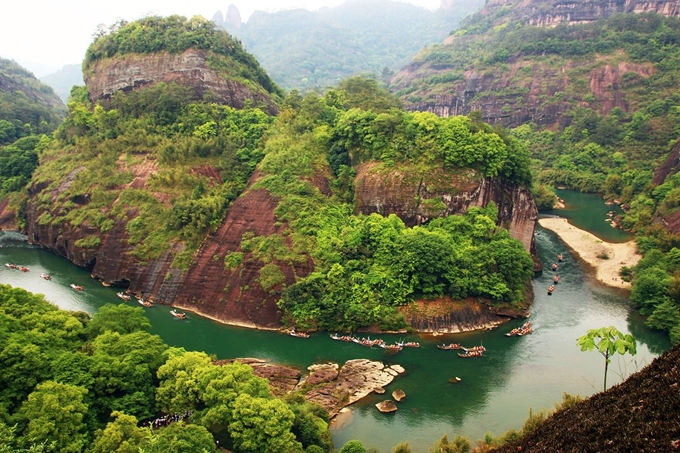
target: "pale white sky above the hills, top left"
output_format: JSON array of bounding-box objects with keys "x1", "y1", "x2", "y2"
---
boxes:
[{"x1": 0, "y1": 0, "x2": 440, "y2": 77}]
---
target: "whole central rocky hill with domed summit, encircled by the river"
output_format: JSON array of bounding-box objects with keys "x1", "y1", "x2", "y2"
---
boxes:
[{"x1": 0, "y1": 16, "x2": 536, "y2": 331}]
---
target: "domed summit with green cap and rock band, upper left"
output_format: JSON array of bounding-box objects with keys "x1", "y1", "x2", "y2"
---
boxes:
[{"x1": 83, "y1": 15, "x2": 283, "y2": 114}]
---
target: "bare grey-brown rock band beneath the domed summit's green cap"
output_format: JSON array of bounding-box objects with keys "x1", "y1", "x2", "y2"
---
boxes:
[{"x1": 85, "y1": 49, "x2": 278, "y2": 114}]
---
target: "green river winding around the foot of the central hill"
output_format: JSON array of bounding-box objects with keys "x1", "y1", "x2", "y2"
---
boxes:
[{"x1": 0, "y1": 191, "x2": 670, "y2": 453}]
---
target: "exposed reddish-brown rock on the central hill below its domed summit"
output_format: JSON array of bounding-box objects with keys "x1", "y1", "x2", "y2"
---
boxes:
[{"x1": 26, "y1": 157, "x2": 537, "y2": 331}]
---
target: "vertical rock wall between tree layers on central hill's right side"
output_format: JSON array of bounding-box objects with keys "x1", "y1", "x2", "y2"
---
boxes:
[{"x1": 355, "y1": 163, "x2": 538, "y2": 255}]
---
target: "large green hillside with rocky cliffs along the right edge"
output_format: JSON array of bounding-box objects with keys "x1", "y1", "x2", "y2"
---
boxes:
[{"x1": 392, "y1": 0, "x2": 680, "y2": 342}]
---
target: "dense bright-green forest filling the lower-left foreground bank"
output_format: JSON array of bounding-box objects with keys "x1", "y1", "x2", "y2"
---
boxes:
[{"x1": 0, "y1": 285, "x2": 333, "y2": 453}]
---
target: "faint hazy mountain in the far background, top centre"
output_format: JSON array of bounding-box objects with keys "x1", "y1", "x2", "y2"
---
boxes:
[{"x1": 213, "y1": 0, "x2": 484, "y2": 91}]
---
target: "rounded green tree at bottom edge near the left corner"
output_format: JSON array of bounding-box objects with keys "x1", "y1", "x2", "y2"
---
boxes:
[{"x1": 20, "y1": 381, "x2": 88, "y2": 453}]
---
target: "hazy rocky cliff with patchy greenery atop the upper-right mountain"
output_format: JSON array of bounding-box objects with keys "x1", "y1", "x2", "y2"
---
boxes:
[{"x1": 391, "y1": 0, "x2": 680, "y2": 127}]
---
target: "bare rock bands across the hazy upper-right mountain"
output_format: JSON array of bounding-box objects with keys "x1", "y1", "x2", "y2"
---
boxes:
[{"x1": 391, "y1": 0, "x2": 680, "y2": 128}]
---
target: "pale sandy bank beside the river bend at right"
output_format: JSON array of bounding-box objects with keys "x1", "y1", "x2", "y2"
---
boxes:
[{"x1": 538, "y1": 218, "x2": 642, "y2": 289}]
